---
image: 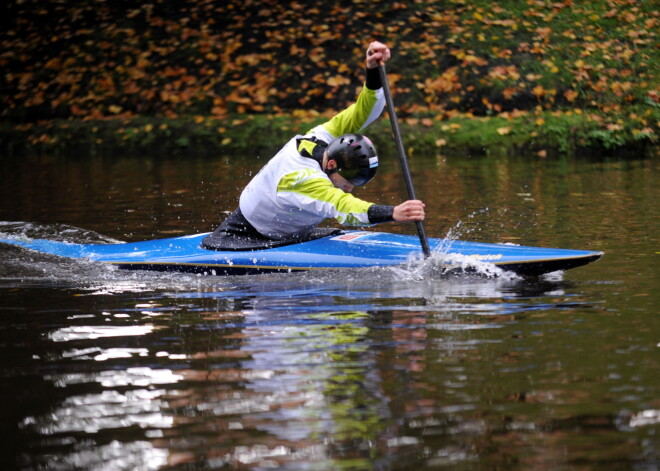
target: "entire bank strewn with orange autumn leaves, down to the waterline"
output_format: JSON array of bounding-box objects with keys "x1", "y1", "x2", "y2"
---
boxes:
[{"x1": 0, "y1": 0, "x2": 660, "y2": 158}]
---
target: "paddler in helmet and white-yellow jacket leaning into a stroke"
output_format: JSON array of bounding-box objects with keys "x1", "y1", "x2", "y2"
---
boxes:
[{"x1": 202, "y1": 41, "x2": 424, "y2": 248}]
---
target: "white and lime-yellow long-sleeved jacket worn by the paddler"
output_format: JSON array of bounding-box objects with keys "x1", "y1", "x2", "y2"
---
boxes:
[{"x1": 239, "y1": 76, "x2": 389, "y2": 240}]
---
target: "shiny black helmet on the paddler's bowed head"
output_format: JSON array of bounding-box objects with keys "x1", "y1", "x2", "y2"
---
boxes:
[{"x1": 328, "y1": 134, "x2": 378, "y2": 186}]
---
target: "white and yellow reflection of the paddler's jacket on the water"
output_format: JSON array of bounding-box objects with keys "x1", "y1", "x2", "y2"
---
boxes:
[{"x1": 159, "y1": 306, "x2": 385, "y2": 466}]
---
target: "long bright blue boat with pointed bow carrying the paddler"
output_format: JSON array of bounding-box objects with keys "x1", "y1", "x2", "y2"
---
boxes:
[{"x1": 0, "y1": 231, "x2": 603, "y2": 276}]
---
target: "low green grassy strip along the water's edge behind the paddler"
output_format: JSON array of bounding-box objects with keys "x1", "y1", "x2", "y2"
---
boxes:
[{"x1": 0, "y1": 105, "x2": 660, "y2": 157}]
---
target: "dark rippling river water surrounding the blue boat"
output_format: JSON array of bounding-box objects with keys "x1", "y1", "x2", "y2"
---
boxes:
[{"x1": 0, "y1": 146, "x2": 660, "y2": 470}]
